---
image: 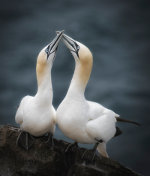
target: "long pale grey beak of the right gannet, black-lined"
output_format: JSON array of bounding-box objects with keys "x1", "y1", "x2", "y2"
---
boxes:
[{"x1": 56, "y1": 31, "x2": 80, "y2": 57}]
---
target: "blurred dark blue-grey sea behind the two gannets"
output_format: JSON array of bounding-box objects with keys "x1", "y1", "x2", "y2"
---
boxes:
[{"x1": 0, "y1": 0, "x2": 150, "y2": 176}]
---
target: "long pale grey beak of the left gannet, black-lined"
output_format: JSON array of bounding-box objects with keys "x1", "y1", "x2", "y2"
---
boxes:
[{"x1": 45, "y1": 30, "x2": 64, "y2": 58}]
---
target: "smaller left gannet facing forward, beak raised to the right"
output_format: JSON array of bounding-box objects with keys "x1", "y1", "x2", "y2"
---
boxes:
[{"x1": 15, "y1": 31, "x2": 63, "y2": 150}]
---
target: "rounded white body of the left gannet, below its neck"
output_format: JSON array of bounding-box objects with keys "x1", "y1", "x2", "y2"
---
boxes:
[{"x1": 15, "y1": 95, "x2": 56, "y2": 136}]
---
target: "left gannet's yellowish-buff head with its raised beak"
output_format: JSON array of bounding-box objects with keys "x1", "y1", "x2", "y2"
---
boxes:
[{"x1": 36, "y1": 31, "x2": 64, "y2": 83}]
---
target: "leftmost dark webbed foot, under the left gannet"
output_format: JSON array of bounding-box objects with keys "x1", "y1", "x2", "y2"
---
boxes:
[{"x1": 16, "y1": 131, "x2": 34, "y2": 150}]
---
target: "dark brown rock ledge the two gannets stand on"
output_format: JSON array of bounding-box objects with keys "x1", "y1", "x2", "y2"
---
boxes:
[{"x1": 0, "y1": 126, "x2": 142, "y2": 176}]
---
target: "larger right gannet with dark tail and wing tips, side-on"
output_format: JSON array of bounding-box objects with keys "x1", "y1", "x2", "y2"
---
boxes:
[{"x1": 56, "y1": 32, "x2": 138, "y2": 157}]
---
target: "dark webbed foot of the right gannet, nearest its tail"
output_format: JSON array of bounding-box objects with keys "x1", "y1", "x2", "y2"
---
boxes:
[{"x1": 81, "y1": 139, "x2": 103, "y2": 162}]
